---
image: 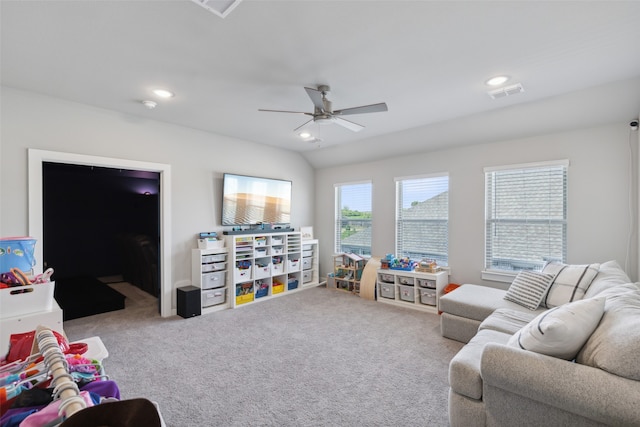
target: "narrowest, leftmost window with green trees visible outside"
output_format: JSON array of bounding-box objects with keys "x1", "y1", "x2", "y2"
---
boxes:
[{"x1": 335, "y1": 182, "x2": 371, "y2": 256}]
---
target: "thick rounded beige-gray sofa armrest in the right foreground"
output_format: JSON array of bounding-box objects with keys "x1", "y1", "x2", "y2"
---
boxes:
[{"x1": 480, "y1": 343, "x2": 640, "y2": 425}]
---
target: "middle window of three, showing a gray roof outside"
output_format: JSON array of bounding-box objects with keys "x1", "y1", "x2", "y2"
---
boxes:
[{"x1": 396, "y1": 175, "x2": 449, "y2": 265}]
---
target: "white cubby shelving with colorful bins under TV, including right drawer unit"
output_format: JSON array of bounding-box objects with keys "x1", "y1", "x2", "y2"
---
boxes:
[{"x1": 225, "y1": 232, "x2": 320, "y2": 308}]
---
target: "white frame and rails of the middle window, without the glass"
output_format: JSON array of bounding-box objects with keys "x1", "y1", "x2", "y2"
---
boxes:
[{"x1": 394, "y1": 172, "x2": 450, "y2": 266}]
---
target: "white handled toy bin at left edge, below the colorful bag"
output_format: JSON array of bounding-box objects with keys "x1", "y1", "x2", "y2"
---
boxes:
[{"x1": 0, "y1": 282, "x2": 55, "y2": 318}]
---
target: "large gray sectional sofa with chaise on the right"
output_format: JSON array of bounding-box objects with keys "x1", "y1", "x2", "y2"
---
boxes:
[{"x1": 440, "y1": 261, "x2": 640, "y2": 427}]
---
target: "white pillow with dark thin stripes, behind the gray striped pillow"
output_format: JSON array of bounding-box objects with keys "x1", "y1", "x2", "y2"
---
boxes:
[{"x1": 542, "y1": 262, "x2": 600, "y2": 308}]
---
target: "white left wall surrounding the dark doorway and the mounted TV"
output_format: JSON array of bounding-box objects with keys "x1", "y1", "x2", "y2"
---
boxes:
[{"x1": 0, "y1": 87, "x2": 314, "y2": 306}]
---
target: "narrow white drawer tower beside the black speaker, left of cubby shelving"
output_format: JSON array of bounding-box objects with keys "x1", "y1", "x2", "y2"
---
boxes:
[{"x1": 191, "y1": 247, "x2": 229, "y2": 314}]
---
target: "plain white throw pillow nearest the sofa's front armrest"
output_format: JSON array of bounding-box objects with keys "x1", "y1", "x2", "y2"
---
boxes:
[{"x1": 507, "y1": 297, "x2": 606, "y2": 360}]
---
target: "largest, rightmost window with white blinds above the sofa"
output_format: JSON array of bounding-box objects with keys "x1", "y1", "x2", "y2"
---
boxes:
[{"x1": 485, "y1": 161, "x2": 569, "y2": 271}]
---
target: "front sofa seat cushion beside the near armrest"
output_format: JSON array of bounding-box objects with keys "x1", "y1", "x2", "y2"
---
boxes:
[{"x1": 449, "y1": 329, "x2": 511, "y2": 399}]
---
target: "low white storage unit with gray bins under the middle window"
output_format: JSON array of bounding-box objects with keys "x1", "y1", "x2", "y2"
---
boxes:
[{"x1": 376, "y1": 269, "x2": 449, "y2": 313}]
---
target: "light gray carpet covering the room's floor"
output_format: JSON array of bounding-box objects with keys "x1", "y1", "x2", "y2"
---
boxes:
[{"x1": 64, "y1": 284, "x2": 462, "y2": 427}]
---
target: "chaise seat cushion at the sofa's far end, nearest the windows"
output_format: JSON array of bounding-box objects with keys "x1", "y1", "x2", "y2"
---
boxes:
[{"x1": 439, "y1": 285, "x2": 544, "y2": 322}]
